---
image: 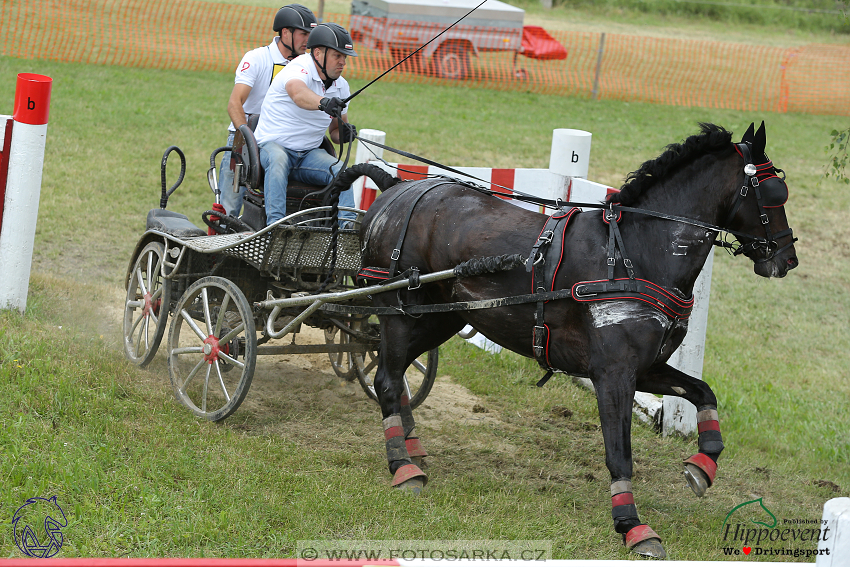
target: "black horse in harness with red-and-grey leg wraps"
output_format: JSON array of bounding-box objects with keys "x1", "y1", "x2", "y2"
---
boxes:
[{"x1": 346, "y1": 123, "x2": 798, "y2": 557}]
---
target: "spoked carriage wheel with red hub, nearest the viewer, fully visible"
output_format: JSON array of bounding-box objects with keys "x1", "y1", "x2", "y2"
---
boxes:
[{"x1": 168, "y1": 276, "x2": 257, "y2": 421}]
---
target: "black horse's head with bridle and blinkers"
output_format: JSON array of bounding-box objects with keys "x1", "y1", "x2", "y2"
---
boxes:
[{"x1": 725, "y1": 122, "x2": 799, "y2": 278}]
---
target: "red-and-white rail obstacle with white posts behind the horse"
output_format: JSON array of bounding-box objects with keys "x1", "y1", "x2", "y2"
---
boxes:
[{"x1": 354, "y1": 128, "x2": 714, "y2": 436}]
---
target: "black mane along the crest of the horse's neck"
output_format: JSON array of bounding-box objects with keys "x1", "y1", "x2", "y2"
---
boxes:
[{"x1": 607, "y1": 122, "x2": 732, "y2": 206}]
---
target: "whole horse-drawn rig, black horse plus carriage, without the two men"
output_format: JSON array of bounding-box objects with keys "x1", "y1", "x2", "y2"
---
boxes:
[{"x1": 124, "y1": 116, "x2": 799, "y2": 558}]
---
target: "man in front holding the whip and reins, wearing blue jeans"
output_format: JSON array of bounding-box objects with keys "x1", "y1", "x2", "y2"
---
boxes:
[{"x1": 254, "y1": 23, "x2": 357, "y2": 226}]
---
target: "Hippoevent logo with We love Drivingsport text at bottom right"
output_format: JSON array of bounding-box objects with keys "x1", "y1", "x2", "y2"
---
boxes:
[{"x1": 722, "y1": 498, "x2": 834, "y2": 559}]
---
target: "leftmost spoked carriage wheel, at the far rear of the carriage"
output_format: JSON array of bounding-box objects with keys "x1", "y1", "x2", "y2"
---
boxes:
[{"x1": 124, "y1": 242, "x2": 171, "y2": 367}]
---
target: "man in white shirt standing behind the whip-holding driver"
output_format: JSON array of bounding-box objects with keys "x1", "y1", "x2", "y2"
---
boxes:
[{"x1": 218, "y1": 4, "x2": 317, "y2": 216}]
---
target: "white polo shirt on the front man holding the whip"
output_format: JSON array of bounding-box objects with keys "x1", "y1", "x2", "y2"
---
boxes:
[{"x1": 254, "y1": 53, "x2": 351, "y2": 151}]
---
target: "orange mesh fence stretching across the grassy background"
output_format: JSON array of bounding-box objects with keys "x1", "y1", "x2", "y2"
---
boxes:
[{"x1": 0, "y1": 0, "x2": 850, "y2": 116}]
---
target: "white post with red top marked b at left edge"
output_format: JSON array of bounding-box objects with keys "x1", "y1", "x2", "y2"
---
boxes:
[{"x1": 0, "y1": 73, "x2": 53, "y2": 313}]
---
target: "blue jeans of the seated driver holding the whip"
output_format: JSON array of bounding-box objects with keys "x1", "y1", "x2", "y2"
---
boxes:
[{"x1": 260, "y1": 142, "x2": 357, "y2": 225}]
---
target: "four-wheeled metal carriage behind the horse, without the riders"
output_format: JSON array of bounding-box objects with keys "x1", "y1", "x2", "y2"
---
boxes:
[{"x1": 123, "y1": 130, "x2": 438, "y2": 421}]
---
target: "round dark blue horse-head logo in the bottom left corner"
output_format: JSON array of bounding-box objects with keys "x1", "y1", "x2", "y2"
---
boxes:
[{"x1": 12, "y1": 496, "x2": 68, "y2": 559}]
